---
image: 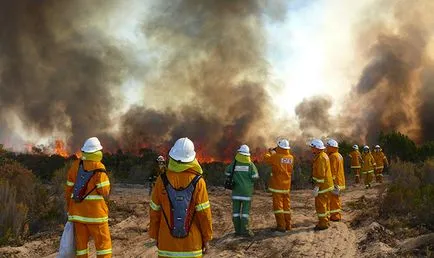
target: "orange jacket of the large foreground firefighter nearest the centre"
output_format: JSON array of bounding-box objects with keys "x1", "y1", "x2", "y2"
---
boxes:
[{"x1": 149, "y1": 169, "x2": 213, "y2": 257}]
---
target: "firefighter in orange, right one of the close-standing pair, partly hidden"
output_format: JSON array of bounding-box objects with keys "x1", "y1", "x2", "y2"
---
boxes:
[{"x1": 327, "y1": 139, "x2": 345, "y2": 221}]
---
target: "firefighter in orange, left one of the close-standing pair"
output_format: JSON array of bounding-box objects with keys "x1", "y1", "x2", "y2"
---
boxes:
[{"x1": 310, "y1": 139, "x2": 334, "y2": 230}]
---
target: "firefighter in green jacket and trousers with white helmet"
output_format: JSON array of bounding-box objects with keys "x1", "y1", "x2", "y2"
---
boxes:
[{"x1": 225, "y1": 145, "x2": 259, "y2": 236}]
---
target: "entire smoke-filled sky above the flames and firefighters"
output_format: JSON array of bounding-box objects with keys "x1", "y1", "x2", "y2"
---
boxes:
[{"x1": 0, "y1": 0, "x2": 434, "y2": 159}]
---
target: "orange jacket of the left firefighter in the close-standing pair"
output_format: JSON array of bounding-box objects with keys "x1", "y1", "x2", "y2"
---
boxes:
[{"x1": 312, "y1": 151, "x2": 334, "y2": 194}]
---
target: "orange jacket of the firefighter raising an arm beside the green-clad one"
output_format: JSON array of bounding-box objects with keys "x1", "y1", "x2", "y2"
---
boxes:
[{"x1": 264, "y1": 147, "x2": 294, "y2": 193}]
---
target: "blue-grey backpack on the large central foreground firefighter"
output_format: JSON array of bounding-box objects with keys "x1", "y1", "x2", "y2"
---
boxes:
[{"x1": 161, "y1": 173, "x2": 202, "y2": 238}]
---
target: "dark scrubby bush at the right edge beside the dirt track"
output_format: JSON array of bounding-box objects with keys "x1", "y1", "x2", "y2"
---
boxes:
[{"x1": 380, "y1": 160, "x2": 434, "y2": 229}]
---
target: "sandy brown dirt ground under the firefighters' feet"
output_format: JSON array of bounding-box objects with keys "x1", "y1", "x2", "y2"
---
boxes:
[{"x1": 0, "y1": 179, "x2": 420, "y2": 258}]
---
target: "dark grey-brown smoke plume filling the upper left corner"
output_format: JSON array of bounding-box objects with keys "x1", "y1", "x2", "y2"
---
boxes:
[{"x1": 0, "y1": 0, "x2": 124, "y2": 149}]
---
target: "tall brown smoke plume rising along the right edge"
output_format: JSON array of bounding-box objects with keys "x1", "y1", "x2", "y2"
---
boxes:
[{"x1": 347, "y1": 0, "x2": 434, "y2": 142}]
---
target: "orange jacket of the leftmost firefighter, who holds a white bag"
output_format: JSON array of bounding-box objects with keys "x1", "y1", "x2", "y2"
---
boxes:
[{"x1": 65, "y1": 160, "x2": 110, "y2": 224}]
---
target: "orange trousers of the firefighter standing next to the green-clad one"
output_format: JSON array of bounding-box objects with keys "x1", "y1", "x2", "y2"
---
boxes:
[{"x1": 273, "y1": 193, "x2": 291, "y2": 230}]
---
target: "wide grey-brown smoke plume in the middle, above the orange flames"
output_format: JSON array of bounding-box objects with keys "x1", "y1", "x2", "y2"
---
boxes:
[{"x1": 121, "y1": 0, "x2": 285, "y2": 159}]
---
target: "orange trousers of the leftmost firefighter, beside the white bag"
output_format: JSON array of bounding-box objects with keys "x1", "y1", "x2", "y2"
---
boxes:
[{"x1": 74, "y1": 222, "x2": 112, "y2": 258}]
